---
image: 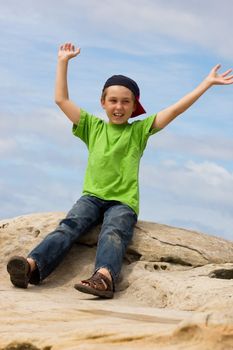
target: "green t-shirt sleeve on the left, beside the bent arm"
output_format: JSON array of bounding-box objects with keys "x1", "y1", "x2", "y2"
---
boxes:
[{"x1": 72, "y1": 109, "x2": 102, "y2": 147}]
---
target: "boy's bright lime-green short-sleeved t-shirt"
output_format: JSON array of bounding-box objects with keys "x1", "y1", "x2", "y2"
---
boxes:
[{"x1": 73, "y1": 110, "x2": 159, "y2": 214}]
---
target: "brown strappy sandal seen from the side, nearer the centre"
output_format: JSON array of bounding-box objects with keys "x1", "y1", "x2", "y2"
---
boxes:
[{"x1": 74, "y1": 272, "x2": 114, "y2": 299}]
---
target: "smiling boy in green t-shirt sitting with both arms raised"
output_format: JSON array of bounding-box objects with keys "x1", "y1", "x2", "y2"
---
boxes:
[{"x1": 7, "y1": 43, "x2": 233, "y2": 298}]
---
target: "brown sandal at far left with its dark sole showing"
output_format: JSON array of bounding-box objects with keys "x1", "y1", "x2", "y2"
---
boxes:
[{"x1": 7, "y1": 256, "x2": 31, "y2": 288}]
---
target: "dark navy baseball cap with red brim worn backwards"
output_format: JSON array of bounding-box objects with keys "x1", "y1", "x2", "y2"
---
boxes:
[{"x1": 103, "y1": 75, "x2": 146, "y2": 118}]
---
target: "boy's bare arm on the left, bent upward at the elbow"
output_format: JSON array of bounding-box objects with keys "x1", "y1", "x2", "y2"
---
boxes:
[{"x1": 55, "y1": 43, "x2": 80, "y2": 124}]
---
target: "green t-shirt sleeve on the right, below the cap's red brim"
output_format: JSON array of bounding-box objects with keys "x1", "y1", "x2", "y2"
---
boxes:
[{"x1": 135, "y1": 114, "x2": 161, "y2": 151}]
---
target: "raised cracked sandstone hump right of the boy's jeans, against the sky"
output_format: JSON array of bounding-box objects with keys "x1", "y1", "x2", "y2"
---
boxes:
[{"x1": 130, "y1": 221, "x2": 233, "y2": 266}]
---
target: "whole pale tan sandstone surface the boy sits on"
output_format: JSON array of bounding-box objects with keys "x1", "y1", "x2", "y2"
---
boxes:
[{"x1": 0, "y1": 213, "x2": 233, "y2": 350}]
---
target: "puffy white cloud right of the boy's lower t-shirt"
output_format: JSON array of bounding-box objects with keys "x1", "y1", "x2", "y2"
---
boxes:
[{"x1": 141, "y1": 160, "x2": 233, "y2": 211}]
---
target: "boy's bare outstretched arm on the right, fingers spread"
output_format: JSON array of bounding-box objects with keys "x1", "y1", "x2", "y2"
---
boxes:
[{"x1": 152, "y1": 64, "x2": 233, "y2": 129}]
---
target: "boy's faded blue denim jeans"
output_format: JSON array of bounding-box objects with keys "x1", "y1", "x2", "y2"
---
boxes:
[{"x1": 28, "y1": 195, "x2": 137, "y2": 284}]
